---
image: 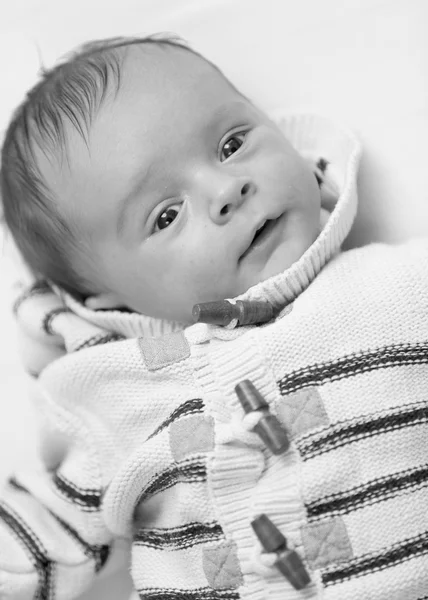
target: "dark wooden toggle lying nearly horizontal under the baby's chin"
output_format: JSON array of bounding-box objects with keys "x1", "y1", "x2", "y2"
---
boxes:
[{"x1": 192, "y1": 300, "x2": 273, "y2": 327}]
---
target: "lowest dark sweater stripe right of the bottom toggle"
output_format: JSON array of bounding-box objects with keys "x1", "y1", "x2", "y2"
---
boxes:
[{"x1": 321, "y1": 532, "x2": 428, "y2": 586}]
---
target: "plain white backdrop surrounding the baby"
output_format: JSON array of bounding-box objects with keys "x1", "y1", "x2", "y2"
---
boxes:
[{"x1": 0, "y1": 0, "x2": 428, "y2": 600}]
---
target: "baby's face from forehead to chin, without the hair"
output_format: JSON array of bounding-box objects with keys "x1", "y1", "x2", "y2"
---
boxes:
[{"x1": 46, "y1": 48, "x2": 320, "y2": 322}]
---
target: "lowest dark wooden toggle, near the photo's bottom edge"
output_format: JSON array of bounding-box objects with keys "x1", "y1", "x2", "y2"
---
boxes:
[{"x1": 251, "y1": 514, "x2": 311, "y2": 590}]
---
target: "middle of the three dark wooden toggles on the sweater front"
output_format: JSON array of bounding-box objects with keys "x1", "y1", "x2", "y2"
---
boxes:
[{"x1": 235, "y1": 379, "x2": 290, "y2": 454}]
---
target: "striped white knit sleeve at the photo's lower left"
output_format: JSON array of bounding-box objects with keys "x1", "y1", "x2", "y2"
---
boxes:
[{"x1": 0, "y1": 386, "x2": 113, "y2": 600}]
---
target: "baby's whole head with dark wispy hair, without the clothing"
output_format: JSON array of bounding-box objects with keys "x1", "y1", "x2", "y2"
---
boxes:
[{"x1": 3, "y1": 34, "x2": 326, "y2": 324}]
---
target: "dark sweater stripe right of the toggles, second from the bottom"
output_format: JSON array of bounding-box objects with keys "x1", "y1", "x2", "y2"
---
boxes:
[{"x1": 306, "y1": 466, "x2": 428, "y2": 520}]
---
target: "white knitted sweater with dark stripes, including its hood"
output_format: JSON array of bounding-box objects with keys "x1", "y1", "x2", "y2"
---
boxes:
[{"x1": 0, "y1": 117, "x2": 428, "y2": 600}]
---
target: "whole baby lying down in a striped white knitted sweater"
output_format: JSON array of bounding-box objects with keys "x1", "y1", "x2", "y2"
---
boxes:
[{"x1": 0, "y1": 37, "x2": 428, "y2": 600}]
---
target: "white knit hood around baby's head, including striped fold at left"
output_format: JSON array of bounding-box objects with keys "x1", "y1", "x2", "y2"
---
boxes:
[{"x1": 15, "y1": 114, "x2": 361, "y2": 374}]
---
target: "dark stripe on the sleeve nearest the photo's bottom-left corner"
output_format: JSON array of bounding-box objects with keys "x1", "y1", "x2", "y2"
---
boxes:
[{"x1": 0, "y1": 502, "x2": 53, "y2": 600}]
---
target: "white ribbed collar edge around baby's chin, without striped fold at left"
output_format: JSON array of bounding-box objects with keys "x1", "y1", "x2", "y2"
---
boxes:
[{"x1": 63, "y1": 113, "x2": 361, "y2": 337}]
